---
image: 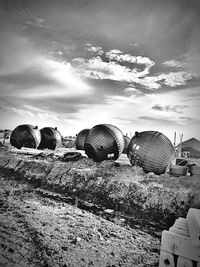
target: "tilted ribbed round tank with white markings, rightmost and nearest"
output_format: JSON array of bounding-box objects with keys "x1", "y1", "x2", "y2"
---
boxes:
[{"x1": 127, "y1": 131, "x2": 175, "y2": 174}]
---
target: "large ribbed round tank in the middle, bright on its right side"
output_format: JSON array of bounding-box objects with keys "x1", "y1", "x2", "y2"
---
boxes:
[{"x1": 84, "y1": 124, "x2": 124, "y2": 161}]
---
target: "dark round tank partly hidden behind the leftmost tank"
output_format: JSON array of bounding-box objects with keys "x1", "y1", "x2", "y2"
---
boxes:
[{"x1": 38, "y1": 127, "x2": 62, "y2": 150}]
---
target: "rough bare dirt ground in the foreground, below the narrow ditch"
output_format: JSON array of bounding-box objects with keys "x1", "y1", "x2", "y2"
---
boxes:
[{"x1": 0, "y1": 171, "x2": 160, "y2": 267}]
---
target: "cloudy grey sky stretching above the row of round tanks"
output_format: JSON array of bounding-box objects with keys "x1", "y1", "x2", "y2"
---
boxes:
[{"x1": 0, "y1": 0, "x2": 200, "y2": 142}]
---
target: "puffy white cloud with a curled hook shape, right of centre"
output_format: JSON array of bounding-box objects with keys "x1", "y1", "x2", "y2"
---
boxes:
[{"x1": 73, "y1": 54, "x2": 194, "y2": 89}]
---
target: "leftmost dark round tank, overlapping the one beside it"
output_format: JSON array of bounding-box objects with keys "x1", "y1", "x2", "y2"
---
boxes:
[{"x1": 10, "y1": 124, "x2": 41, "y2": 149}]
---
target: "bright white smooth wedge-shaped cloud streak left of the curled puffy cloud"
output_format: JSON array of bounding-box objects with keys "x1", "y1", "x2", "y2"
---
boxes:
[{"x1": 16, "y1": 56, "x2": 92, "y2": 98}]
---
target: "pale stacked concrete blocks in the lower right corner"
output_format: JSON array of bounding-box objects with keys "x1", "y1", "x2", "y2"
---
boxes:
[{"x1": 159, "y1": 208, "x2": 200, "y2": 267}]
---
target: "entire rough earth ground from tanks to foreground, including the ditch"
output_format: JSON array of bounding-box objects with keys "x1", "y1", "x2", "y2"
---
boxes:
[{"x1": 0, "y1": 147, "x2": 200, "y2": 267}]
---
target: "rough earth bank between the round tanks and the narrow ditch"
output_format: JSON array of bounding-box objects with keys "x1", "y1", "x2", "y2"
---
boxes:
[{"x1": 0, "y1": 151, "x2": 200, "y2": 227}]
